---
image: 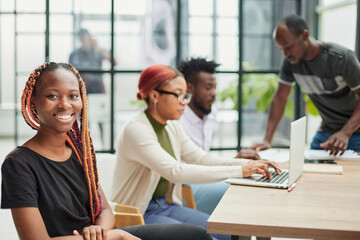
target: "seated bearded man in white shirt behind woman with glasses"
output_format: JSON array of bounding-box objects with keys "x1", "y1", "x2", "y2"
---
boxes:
[{"x1": 178, "y1": 58, "x2": 260, "y2": 214}]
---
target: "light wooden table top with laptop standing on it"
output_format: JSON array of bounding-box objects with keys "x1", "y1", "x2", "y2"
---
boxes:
[{"x1": 207, "y1": 160, "x2": 360, "y2": 240}]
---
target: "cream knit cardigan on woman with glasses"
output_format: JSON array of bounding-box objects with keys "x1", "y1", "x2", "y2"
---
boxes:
[{"x1": 110, "y1": 112, "x2": 249, "y2": 214}]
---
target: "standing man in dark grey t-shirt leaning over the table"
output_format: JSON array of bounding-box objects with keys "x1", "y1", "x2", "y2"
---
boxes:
[{"x1": 252, "y1": 15, "x2": 360, "y2": 155}]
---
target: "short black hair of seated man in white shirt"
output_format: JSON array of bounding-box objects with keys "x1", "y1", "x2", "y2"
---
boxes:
[{"x1": 178, "y1": 58, "x2": 220, "y2": 82}]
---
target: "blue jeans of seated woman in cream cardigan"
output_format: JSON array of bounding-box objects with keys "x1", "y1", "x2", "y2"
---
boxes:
[{"x1": 144, "y1": 197, "x2": 230, "y2": 240}]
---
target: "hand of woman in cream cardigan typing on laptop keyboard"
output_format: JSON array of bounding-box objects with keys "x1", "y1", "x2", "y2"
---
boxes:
[{"x1": 242, "y1": 160, "x2": 281, "y2": 180}]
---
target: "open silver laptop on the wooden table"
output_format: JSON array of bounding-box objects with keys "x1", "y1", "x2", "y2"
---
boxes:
[{"x1": 226, "y1": 117, "x2": 306, "y2": 189}]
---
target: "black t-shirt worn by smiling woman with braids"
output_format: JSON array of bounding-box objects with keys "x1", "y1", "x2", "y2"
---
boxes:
[{"x1": 1, "y1": 147, "x2": 91, "y2": 237}]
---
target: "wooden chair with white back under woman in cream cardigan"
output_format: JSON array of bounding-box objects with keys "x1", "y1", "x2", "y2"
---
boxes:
[{"x1": 97, "y1": 153, "x2": 196, "y2": 228}]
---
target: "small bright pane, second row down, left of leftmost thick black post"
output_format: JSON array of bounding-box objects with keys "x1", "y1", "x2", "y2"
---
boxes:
[{"x1": 16, "y1": 14, "x2": 45, "y2": 33}]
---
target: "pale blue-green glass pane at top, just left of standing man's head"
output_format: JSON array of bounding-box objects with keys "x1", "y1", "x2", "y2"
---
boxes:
[{"x1": 243, "y1": 0, "x2": 273, "y2": 34}]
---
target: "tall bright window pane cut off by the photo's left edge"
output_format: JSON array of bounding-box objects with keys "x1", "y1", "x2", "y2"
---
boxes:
[{"x1": 0, "y1": 15, "x2": 15, "y2": 104}]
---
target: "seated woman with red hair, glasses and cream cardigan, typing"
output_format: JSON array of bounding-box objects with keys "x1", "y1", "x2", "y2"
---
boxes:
[{"x1": 111, "y1": 65, "x2": 280, "y2": 239}]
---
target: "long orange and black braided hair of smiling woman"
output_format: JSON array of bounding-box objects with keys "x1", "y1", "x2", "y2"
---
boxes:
[{"x1": 21, "y1": 62, "x2": 102, "y2": 224}]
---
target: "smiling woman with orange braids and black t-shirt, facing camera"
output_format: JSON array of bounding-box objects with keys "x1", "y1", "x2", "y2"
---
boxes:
[{"x1": 1, "y1": 63, "x2": 210, "y2": 240}]
